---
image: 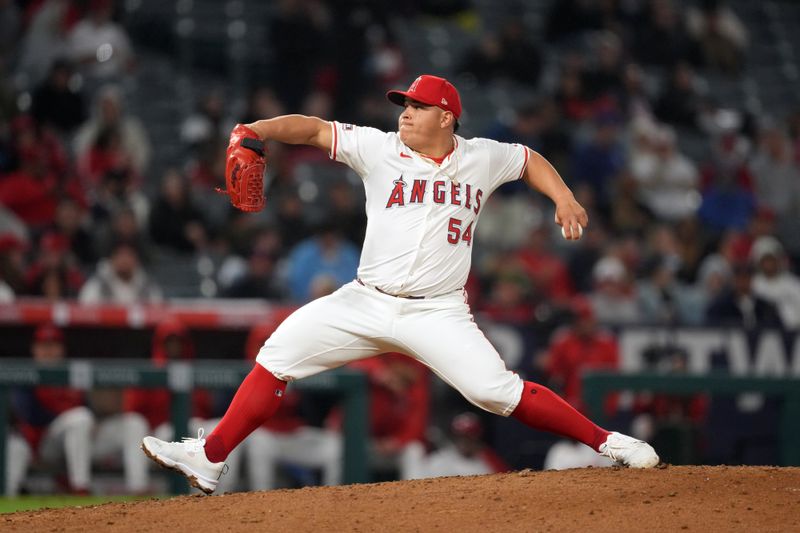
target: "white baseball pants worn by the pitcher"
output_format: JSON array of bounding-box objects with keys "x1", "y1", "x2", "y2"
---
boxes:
[{"x1": 256, "y1": 281, "x2": 523, "y2": 416}]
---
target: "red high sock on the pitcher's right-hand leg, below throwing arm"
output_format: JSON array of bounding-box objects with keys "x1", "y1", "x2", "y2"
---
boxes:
[{"x1": 511, "y1": 381, "x2": 610, "y2": 450}]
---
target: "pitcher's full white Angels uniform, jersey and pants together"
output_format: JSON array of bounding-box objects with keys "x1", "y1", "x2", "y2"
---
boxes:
[{"x1": 256, "y1": 122, "x2": 528, "y2": 416}]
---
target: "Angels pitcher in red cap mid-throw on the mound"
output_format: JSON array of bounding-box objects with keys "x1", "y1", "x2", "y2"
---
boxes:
[{"x1": 142, "y1": 74, "x2": 659, "y2": 494}]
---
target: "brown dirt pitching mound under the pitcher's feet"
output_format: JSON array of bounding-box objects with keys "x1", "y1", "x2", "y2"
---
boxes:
[{"x1": 0, "y1": 466, "x2": 800, "y2": 533}]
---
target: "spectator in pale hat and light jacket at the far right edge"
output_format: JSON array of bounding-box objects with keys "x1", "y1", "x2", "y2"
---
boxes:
[{"x1": 750, "y1": 236, "x2": 800, "y2": 330}]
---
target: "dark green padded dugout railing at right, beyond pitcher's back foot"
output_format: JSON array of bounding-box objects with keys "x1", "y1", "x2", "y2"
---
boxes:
[{"x1": 582, "y1": 371, "x2": 800, "y2": 466}]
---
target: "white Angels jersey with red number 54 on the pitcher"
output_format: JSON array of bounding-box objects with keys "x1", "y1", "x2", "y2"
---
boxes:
[{"x1": 330, "y1": 122, "x2": 528, "y2": 296}]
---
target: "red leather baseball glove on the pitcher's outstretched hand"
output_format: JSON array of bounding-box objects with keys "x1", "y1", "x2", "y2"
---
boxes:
[{"x1": 217, "y1": 124, "x2": 267, "y2": 213}]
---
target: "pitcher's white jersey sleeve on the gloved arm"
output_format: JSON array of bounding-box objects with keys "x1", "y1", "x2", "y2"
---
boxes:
[{"x1": 330, "y1": 121, "x2": 389, "y2": 179}]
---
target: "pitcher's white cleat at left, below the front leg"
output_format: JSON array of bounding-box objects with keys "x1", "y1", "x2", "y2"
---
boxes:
[{"x1": 142, "y1": 428, "x2": 227, "y2": 494}]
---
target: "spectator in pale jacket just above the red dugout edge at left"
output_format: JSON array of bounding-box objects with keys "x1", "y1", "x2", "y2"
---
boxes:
[{"x1": 78, "y1": 241, "x2": 162, "y2": 305}]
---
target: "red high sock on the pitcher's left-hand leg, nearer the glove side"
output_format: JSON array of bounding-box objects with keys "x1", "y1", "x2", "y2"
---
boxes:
[{"x1": 205, "y1": 363, "x2": 286, "y2": 463}]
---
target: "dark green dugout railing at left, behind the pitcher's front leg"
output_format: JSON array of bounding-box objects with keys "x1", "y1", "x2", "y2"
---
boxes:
[{"x1": 0, "y1": 358, "x2": 369, "y2": 494}]
